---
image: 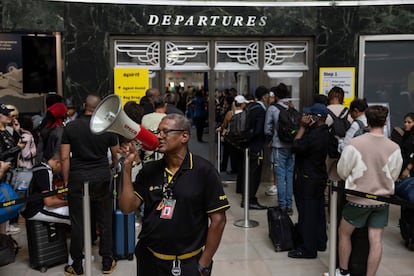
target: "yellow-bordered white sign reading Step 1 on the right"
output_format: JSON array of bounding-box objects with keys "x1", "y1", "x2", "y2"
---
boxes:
[{"x1": 319, "y1": 67, "x2": 355, "y2": 107}]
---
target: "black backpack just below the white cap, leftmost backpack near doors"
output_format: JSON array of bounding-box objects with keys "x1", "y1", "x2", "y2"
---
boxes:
[{"x1": 224, "y1": 105, "x2": 261, "y2": 148}]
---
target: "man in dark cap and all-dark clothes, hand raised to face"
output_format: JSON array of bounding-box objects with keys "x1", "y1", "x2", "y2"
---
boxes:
[{"x1": 288, "y1": 103, "x2": 328, "y2": 259}]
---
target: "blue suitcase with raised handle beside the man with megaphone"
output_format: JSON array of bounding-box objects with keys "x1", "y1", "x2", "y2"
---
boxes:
[{"x1": 112, "y1": 159, "x2": 135, "y2": 261}]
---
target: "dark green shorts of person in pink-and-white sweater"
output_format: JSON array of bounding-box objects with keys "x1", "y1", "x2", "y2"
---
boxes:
[{"x1": 342, "y1": 202, "x2": 389, "y2": 228}]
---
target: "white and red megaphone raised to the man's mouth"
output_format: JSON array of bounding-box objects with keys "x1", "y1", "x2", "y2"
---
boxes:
[{"x1": 89, "y1": 94, "x2": 159, "y2": 150}]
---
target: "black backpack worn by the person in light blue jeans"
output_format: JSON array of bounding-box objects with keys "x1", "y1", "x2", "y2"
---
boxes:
[{"x1": 275, "y1": 104, "x2": 302, "y2": 143}]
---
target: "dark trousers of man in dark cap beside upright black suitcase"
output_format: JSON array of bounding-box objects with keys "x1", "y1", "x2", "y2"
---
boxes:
[{"x1": 295, "y1": 195, "x2": 328, "y2": 256}]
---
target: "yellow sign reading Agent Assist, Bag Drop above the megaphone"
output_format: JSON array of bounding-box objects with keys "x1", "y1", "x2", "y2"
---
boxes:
[{"x1": 114, "y1": 68, "x2": 149, "y2": 106}]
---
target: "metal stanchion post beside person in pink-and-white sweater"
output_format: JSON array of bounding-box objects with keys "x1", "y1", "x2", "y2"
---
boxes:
[{"x1": 329, "y1": 181, "x2": 338, "y2": 275}]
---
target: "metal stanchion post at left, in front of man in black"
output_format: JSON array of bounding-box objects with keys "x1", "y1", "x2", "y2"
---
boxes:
[{"x1": 83, "y1": 181, "x2": 92, "y2": 276}]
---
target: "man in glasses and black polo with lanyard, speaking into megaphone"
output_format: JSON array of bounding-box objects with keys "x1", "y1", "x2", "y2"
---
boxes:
[{"x1": 119, "y1": 114, "x2": 230, "y2": 276}]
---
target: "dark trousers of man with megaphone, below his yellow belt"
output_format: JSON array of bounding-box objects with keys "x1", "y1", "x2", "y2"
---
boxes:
[{"x1": 135, "y1": 242, "x2": 201, "y2": 276}]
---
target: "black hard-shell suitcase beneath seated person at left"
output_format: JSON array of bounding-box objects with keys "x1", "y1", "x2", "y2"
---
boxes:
[{"x1": 26, "y1": 220, "x2": 68, "y2": 272}]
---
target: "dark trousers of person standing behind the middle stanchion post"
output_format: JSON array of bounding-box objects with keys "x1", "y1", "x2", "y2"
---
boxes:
[{"x1": 237, "y1": 153, "x2": 263, "y2": 203}]
